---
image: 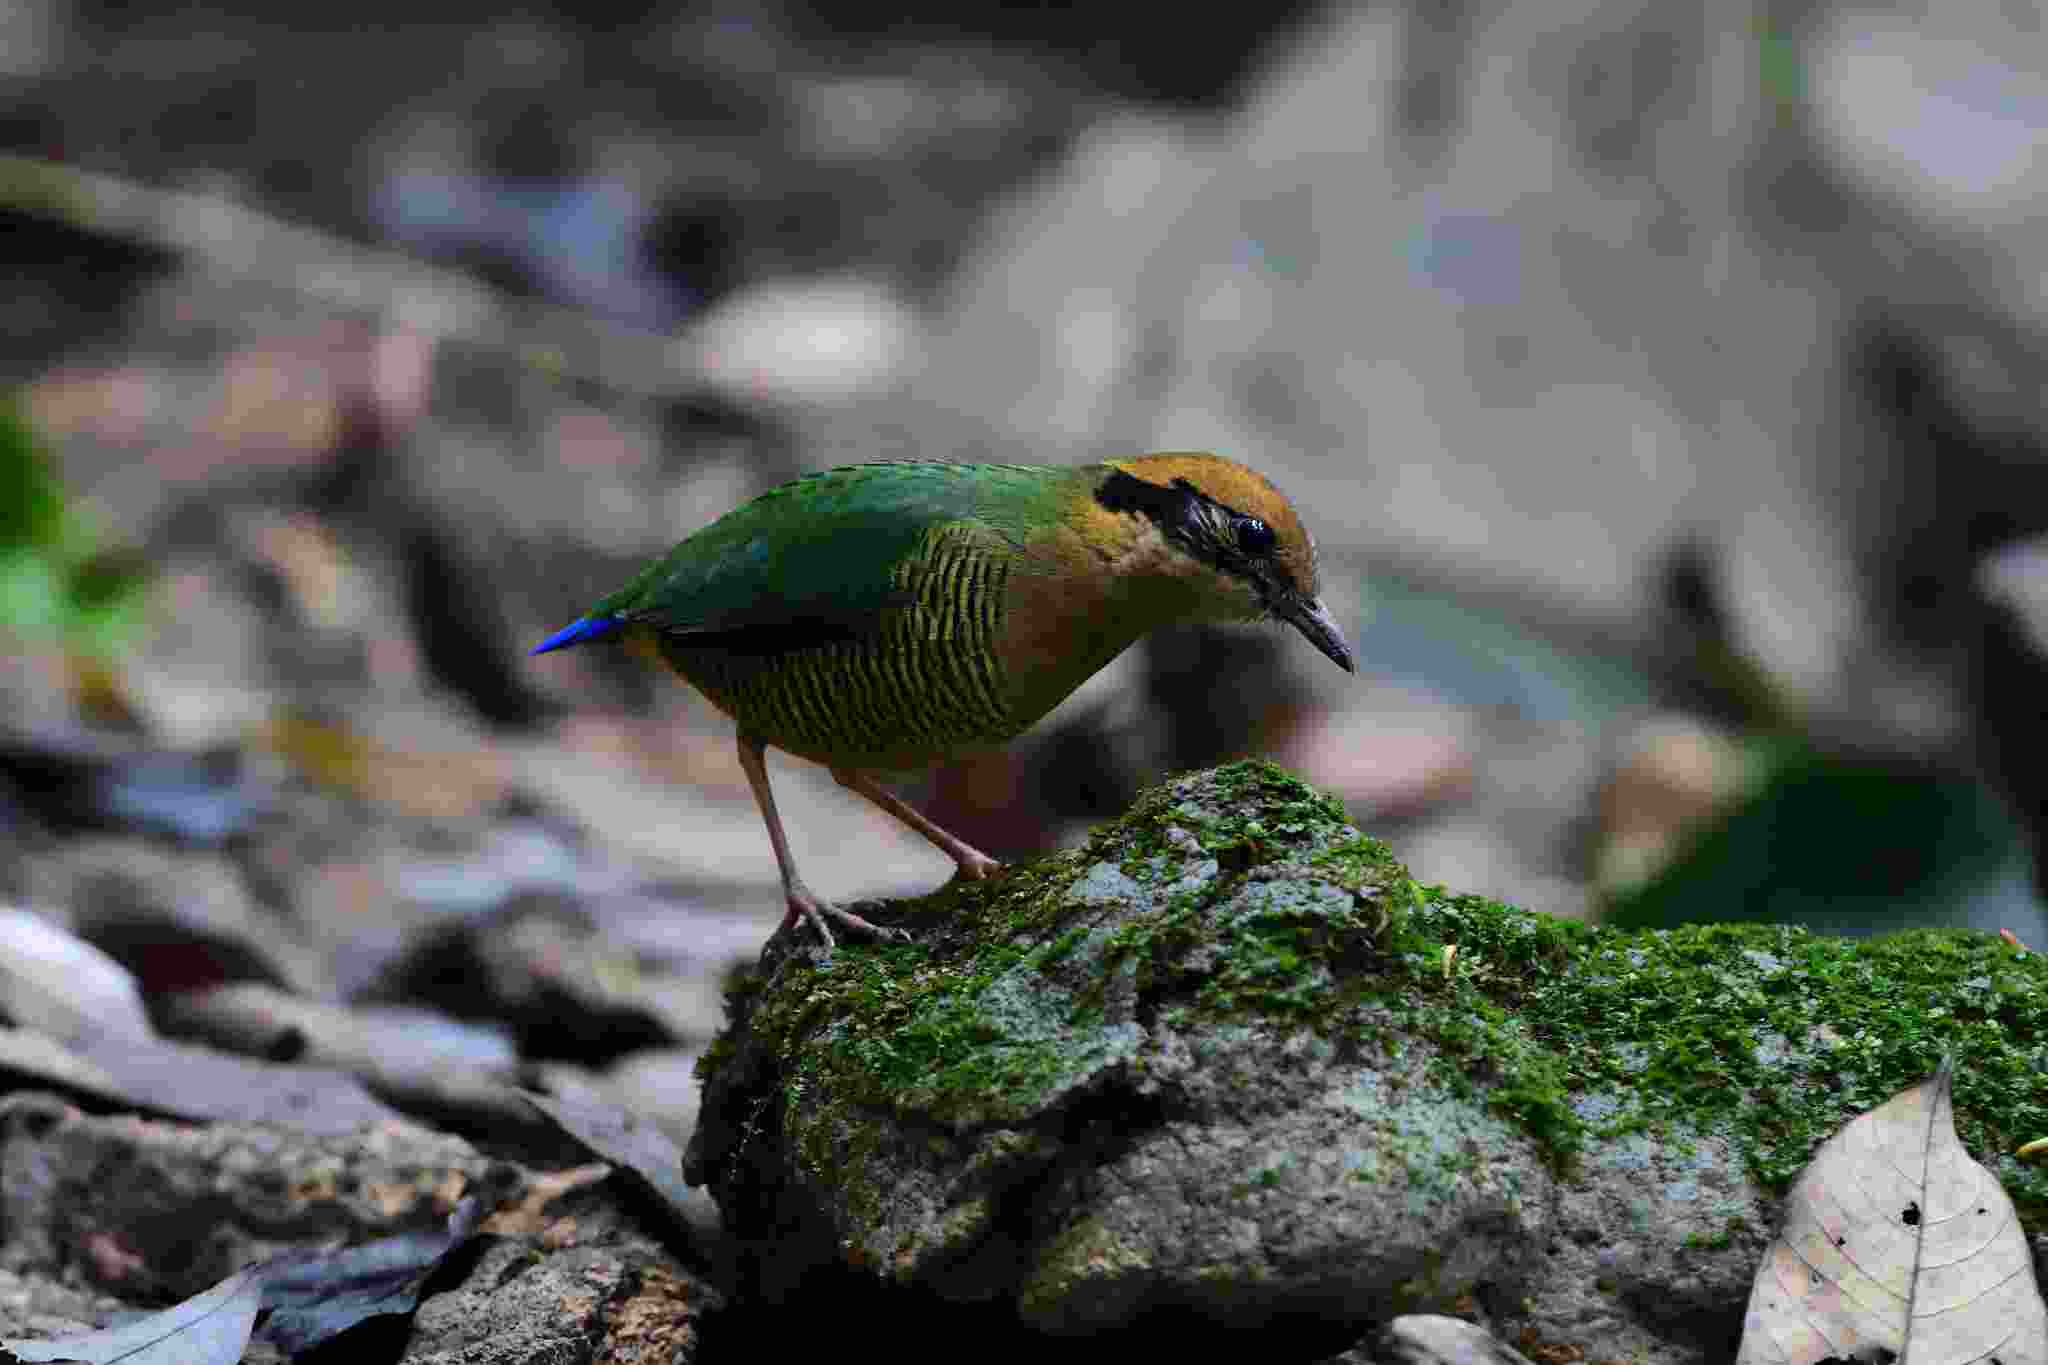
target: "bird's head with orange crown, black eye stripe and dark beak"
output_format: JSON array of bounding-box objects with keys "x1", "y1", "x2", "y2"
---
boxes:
[{"x1": 1096, "y1": 452, "x2": 1358, "y2": 673}]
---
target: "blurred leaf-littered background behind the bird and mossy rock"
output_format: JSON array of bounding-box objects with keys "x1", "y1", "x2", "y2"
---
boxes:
[{"x1": 0, "y1": 0, "x2": 2048, "y2": 1085}]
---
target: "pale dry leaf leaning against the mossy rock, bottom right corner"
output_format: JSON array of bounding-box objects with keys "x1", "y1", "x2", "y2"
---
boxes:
[{"x1": 1737, "y1": 1062, "x2": 2048, "y2": 1365}]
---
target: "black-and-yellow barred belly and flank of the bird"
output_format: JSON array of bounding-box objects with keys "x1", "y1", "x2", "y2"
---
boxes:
[{"x1": 657, "y1": 528, "x2": 1024, "y2": 767}]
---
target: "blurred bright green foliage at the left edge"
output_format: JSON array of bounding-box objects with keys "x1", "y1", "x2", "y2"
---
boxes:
[{"x1": 0, "y1": 397, "x2": 143, "y2": 653}]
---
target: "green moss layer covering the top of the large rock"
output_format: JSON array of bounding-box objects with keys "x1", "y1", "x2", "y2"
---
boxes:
[{"x1": 700, "y1": 761, "x2": 2048, "y2": 1232}]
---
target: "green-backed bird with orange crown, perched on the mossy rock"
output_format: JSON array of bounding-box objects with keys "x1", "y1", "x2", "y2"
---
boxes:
[{"x1": 530, "y1": 452, "x2": 1358, "y2": 952}]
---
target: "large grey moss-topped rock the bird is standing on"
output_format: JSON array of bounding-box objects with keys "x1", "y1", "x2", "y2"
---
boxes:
[{"x1": 686, "y1": 763, "x2": 2048, "y2": 1365}]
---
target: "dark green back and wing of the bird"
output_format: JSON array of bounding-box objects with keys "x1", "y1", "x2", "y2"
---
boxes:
[{"x1": 590, "y1": 465, "x2": 1081, "y2": 649}]
